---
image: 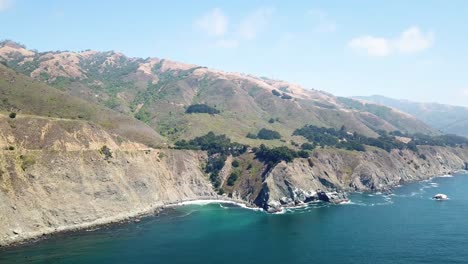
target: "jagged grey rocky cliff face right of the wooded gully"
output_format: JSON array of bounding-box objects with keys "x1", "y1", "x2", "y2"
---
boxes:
[{"x1": 255, "y1": 146, "x2": 468, "y2": 210}]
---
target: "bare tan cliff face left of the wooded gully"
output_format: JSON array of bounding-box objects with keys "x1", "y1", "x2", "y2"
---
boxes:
[{"x1": 0, "y1": 114, "x2": 216, "y2": 245}]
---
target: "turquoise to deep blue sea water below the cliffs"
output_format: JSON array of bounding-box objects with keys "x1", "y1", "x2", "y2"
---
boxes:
[{"x1": 0, "y1": 175, "x2": 468, "y2": 264}]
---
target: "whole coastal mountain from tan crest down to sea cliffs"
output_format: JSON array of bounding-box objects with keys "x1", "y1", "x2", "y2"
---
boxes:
[{"x1": 0, "y1": 41, "x2": 468, "y2": 246}]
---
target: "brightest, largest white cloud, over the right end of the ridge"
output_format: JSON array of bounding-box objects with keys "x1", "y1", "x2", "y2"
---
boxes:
[{"x1": 348, "y1": 26, "x2": 435, "y2": 57}]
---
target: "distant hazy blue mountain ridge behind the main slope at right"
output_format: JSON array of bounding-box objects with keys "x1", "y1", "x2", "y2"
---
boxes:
[{"x1": 354, "y1": 95, "x2": 468, "y2": 137}]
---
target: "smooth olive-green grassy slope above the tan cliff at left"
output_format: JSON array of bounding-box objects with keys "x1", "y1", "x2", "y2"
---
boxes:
[{"x1": 0, "y1": 65, "x2": 163, "y2": 146}]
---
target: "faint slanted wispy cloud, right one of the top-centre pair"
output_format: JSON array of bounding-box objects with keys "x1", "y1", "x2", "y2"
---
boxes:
[{"x1": 238, "y1": 8, "x2": 274, "y2": 39}]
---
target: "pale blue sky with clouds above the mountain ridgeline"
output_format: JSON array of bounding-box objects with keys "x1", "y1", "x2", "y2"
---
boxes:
[{"x1": 0, "y1": 0, "x2": 468, "y2": 106}]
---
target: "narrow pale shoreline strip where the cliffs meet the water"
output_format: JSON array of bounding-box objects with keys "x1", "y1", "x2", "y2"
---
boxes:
[{"x1": 0, "y1": 170, "x2": 468, "y2": 251}]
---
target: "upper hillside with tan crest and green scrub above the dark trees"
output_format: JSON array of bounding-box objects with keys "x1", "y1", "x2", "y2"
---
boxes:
[{"x1": 0, "y1": 41, "x2": 437, "y2": 146}]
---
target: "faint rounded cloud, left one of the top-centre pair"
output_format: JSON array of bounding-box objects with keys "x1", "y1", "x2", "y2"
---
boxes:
[{"x1": 194, "y1": 8, "x2": 229, "y2": 36}]
